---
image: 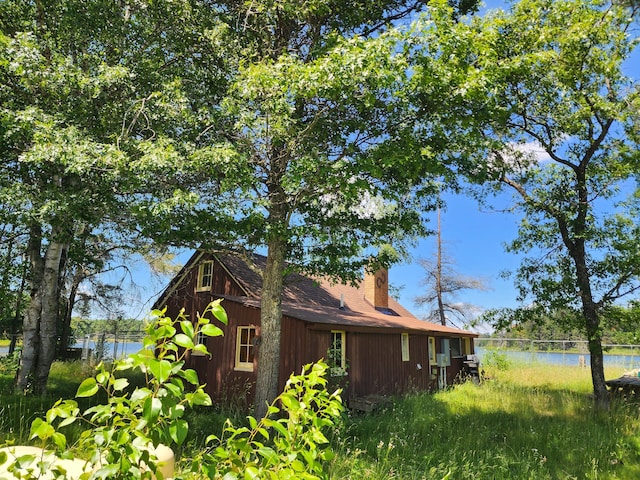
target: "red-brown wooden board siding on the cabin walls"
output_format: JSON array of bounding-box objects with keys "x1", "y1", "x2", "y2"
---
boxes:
[{"x1": 158, "y1": 253, "x2": 473, "y2": 405}]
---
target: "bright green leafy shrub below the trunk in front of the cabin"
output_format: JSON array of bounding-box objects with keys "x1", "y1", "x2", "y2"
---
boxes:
[{"x1": 191, "y1": 362, "x2": 343, "y2": 480}]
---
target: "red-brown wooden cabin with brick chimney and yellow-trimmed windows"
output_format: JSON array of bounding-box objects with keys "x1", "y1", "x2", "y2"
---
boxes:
[{"x1": 155, "y1": 251, "x2": 477, "y2": 405}]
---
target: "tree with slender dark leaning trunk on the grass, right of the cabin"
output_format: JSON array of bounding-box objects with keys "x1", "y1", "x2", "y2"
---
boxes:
[{"x1": 415, "y1": 0, "x2": 640, "y2": 406}]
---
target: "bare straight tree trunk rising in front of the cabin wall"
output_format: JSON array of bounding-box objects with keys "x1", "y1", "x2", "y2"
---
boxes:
[{"x1": 255, "y1": 235, "x2": 286, "y2": 418}]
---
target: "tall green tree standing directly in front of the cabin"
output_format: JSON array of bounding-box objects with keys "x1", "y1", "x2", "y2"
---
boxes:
[{"x1": 140, "y1": 0, "x2": 484, "y2": 415}]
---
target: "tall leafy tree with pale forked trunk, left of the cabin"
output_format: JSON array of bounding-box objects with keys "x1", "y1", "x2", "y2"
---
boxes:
[{"x1": 0, "y1": 0, "x2": 225, "y2": 392}]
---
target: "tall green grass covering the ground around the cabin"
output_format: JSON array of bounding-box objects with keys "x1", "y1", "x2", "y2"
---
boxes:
[{"x1": 0, "y1": 363, "x2": 640, "y2": 480}]
